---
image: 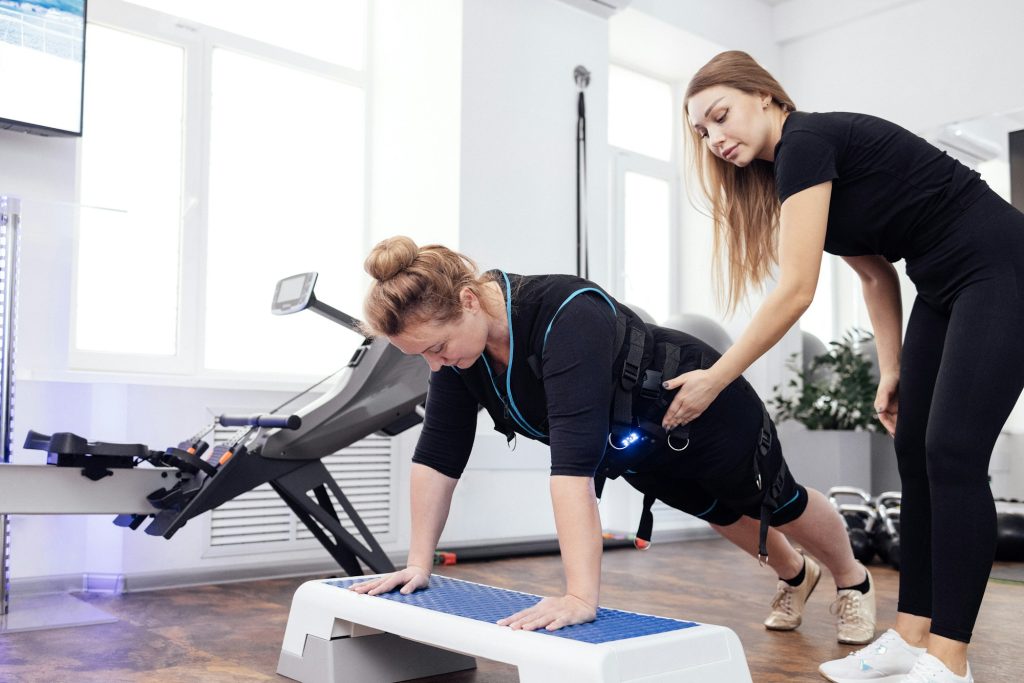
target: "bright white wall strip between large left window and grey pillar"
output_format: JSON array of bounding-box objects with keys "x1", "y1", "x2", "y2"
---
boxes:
[{"x1": 370, "y1": 0, "x2": 463, "y2": 249}]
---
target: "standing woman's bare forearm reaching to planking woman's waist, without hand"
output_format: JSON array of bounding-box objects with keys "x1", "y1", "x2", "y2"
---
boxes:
[{"x1": 709, "y1": 287, "x2": 811, "y2": 389}]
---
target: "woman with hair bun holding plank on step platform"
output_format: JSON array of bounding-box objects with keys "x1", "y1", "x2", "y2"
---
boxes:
[{"x1": 353, "y1": 238, "x2": 874, "y2": 643}]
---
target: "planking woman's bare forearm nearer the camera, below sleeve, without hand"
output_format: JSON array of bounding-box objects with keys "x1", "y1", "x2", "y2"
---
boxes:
[{"x1": 551, "y1": 475, "x2": 603, "y2": 608}]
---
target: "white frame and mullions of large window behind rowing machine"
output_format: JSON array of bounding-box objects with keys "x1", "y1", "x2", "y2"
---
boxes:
[{"x1": 67, "y1": 0, "x2": 373, "y2": 386}]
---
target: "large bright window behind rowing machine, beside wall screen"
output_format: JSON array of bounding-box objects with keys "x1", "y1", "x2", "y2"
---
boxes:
[{"x1": 71, "y1": 0, "x2": 368, "y2": 376}]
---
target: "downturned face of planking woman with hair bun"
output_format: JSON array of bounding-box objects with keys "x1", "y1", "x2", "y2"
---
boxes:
[{"x1": 388, "y1": 289, "x2": 487, "y2": 372}]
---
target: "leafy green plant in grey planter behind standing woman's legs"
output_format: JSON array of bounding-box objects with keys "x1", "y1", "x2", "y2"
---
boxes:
[{"x1": 768, "y1": 329, "x2": 900, "y2": 494}]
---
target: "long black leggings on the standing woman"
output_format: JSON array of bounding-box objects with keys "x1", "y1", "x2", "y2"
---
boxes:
[{"x1": 896, "y1": 189, "x2": 1024, "y2": 643}]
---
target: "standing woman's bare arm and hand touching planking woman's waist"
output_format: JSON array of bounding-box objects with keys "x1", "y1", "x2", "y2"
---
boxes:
[{"x1": 663, "y1": 181, "x2": 831, "y2": 429}]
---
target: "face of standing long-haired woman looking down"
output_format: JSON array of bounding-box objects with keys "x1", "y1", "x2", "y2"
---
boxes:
[{"x1": 686, "y1": 85, "x2": 775, "y2": 167}]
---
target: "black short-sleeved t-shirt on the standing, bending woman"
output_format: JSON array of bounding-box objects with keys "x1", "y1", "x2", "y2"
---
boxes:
[{"x1": 774, "y1": 112, "x2": 988, "y2": 261}]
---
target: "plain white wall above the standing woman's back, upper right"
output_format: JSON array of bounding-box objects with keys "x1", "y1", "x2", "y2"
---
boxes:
[{"x1": 780, "y1": 0, "x2": 1024, "y2": 131}]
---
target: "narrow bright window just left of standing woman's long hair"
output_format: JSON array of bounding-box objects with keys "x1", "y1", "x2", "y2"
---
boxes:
[{"x1": 608, "y1": 66, "x2": 679, "y2": 323}]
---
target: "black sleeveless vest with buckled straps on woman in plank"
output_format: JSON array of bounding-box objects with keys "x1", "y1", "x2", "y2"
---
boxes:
[{"x1": 458, "y1": 270, "x2": 785, "y2": 557}]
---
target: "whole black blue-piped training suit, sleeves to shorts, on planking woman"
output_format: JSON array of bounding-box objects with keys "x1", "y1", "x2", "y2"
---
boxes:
[{"x1": 413, "y1": 271, "x2": 807, "y2": 555}]
